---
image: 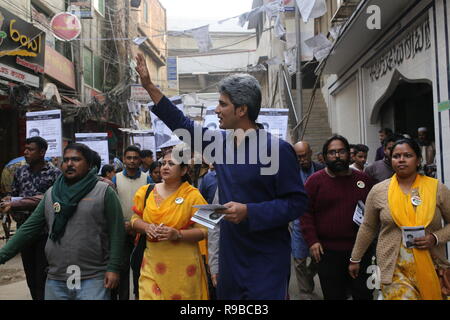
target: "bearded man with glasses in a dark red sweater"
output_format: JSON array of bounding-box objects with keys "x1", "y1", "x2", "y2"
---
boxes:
[{"x1": 300, "y1": 135, "x2": 373, "y2": 300}]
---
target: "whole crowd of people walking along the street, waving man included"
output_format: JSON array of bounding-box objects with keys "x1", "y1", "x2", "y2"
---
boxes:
[{"x1": 0, "y1": 55, "x2": 450, "y2": 300}]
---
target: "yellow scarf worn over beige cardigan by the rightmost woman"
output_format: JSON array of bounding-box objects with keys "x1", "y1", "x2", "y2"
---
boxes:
[{"x1": 388, "y1": 174, "x2": 442, "y2": 300}]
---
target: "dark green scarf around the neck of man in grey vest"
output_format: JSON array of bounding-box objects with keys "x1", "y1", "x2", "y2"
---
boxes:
[{"x1": 50, "y1": 168, "x2": 98, "y2": 242}]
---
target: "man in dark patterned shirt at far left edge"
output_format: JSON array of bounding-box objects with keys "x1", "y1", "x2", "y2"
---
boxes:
[{"x1": 2, "y1": 137, "x2": 61, "y2": 300}]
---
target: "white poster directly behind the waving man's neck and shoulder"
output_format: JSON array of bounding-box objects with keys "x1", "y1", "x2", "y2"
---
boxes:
[{"x1": 256, "y1": 108, "x2": 289, "y2": 140}]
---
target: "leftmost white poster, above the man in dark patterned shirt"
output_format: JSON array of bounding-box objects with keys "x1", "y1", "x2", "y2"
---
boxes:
[{"x1": 26, "y1": 110, "x2": 62, "y2": 157}]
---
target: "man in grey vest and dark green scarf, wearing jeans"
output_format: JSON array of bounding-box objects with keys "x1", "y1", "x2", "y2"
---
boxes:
[{"x1": 0, "y1": 143, "x2": 125, "y2": 300}]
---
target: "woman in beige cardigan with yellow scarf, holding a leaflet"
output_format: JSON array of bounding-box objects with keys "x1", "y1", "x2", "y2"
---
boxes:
[{"x1": 349, "y1": 139, "x2": 450, "y2": 300}]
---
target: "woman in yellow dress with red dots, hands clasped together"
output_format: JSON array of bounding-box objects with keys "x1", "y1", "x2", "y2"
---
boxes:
[{"x1": 131, "y1": 151, "x2": 208, "y2": 300}]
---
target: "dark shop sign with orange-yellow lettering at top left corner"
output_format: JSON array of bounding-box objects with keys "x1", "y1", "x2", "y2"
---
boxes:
[{"x1": 0, "y1": 7, "x2": 45, "y2": 73}]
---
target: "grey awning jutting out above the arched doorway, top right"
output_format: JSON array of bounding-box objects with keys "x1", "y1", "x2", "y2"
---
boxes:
[{"x1": 324, "y1": 0, "x2": 422, "y2": 74}]
